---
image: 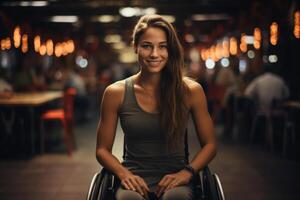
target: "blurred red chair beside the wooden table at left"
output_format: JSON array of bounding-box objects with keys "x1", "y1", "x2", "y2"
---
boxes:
[{"x1": 41, "y1": 88, "x2": 76, "y2": 156}]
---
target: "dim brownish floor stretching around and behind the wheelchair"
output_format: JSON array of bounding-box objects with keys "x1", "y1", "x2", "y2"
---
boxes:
[{"x1": 0, "y1": 118, "x2": 300, "y2": 200}]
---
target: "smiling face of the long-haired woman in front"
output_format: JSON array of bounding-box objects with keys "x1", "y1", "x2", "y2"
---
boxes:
[{"x1": 135, "y1": 27, "x2": 168, "y2": 73}]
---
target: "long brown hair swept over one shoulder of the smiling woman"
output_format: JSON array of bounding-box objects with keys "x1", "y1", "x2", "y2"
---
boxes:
[{"x1": 133, "y1": 15, "x2": 187, "y2": 150}]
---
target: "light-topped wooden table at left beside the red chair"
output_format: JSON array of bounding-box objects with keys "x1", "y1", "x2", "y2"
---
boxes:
[{"x1": 0, "y1": 91, "x2": 63, "y2": 155}]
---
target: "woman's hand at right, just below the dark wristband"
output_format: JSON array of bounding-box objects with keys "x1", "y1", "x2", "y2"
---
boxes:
[{"x1": 155, "y1": 170, "x2": 192, "y2": 197}]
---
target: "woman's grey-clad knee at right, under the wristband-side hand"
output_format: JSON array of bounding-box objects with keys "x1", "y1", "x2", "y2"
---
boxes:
[{"x1": 161, "y1": 186, "x2": 193, "y2": 200}]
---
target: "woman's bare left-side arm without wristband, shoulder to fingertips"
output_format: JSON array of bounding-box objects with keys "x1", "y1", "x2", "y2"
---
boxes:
[{"x1": 96, "y1": 82, "x2": 149, "y2": 195}]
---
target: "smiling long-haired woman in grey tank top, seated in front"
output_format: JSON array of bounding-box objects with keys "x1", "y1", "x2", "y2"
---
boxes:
[{"x1": 96, "y1": 15, "x2": 217, "y2": 200}]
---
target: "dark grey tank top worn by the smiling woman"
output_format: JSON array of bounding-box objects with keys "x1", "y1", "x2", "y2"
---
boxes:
[{"x1": 119, "y1": 77, "x2": 186, "y2": 188}]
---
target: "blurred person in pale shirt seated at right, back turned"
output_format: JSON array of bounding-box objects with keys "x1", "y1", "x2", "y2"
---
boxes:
[{"x1": 244, "y1": 64, "x2": 289, "y2": 113}]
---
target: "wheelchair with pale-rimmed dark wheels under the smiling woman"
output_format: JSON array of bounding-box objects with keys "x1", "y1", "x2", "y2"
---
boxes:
[{"x1": 86, "y1": 134, "x2": 225, "y2": 200}]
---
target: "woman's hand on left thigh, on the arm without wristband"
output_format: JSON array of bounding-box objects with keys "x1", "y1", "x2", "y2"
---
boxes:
[{"x1": 120, "y1": 173, "x2": 150, "y2": 196}]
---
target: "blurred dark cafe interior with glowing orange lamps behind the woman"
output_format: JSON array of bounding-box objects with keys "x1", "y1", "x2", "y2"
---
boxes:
[{"x1": 0, "y1": 0, "x2": 300, "y2": 200}]
